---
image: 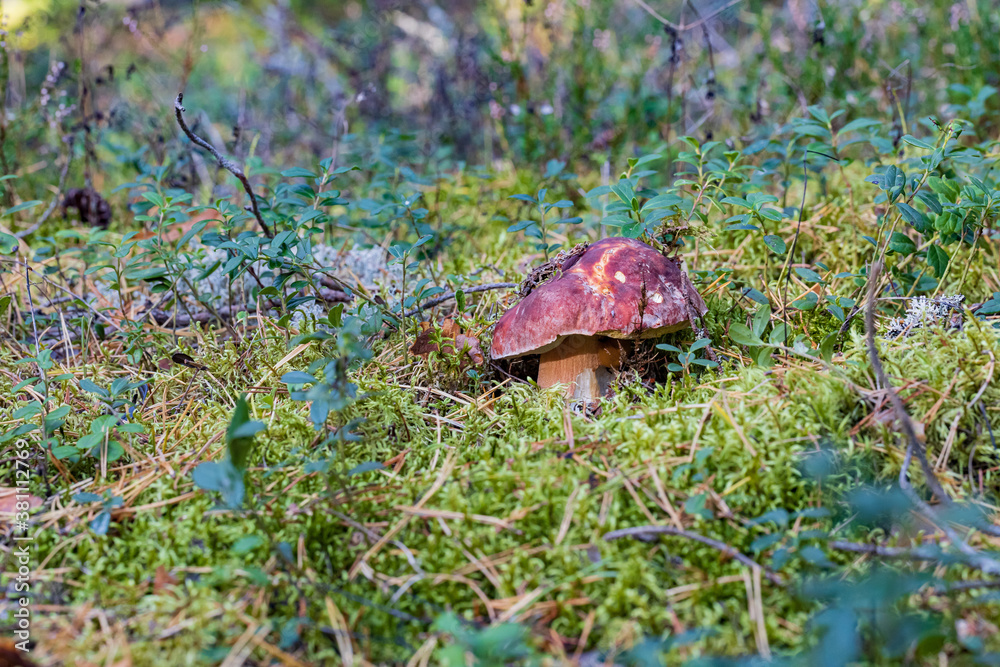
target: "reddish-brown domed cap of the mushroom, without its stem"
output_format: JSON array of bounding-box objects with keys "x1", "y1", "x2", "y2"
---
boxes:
[{"x1": 490, "y1": 237, "x2": 707, "y2": 359}]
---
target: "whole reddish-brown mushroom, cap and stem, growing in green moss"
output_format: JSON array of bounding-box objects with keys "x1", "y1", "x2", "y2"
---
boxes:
[{"x1": 490, "y1": 237, "x2": 707, "y2": 400}]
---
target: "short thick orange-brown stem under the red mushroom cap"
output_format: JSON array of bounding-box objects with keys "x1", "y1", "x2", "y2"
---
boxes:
[{"x1": 538, "y1": 335, "x2": 621, "y2": 400}]
